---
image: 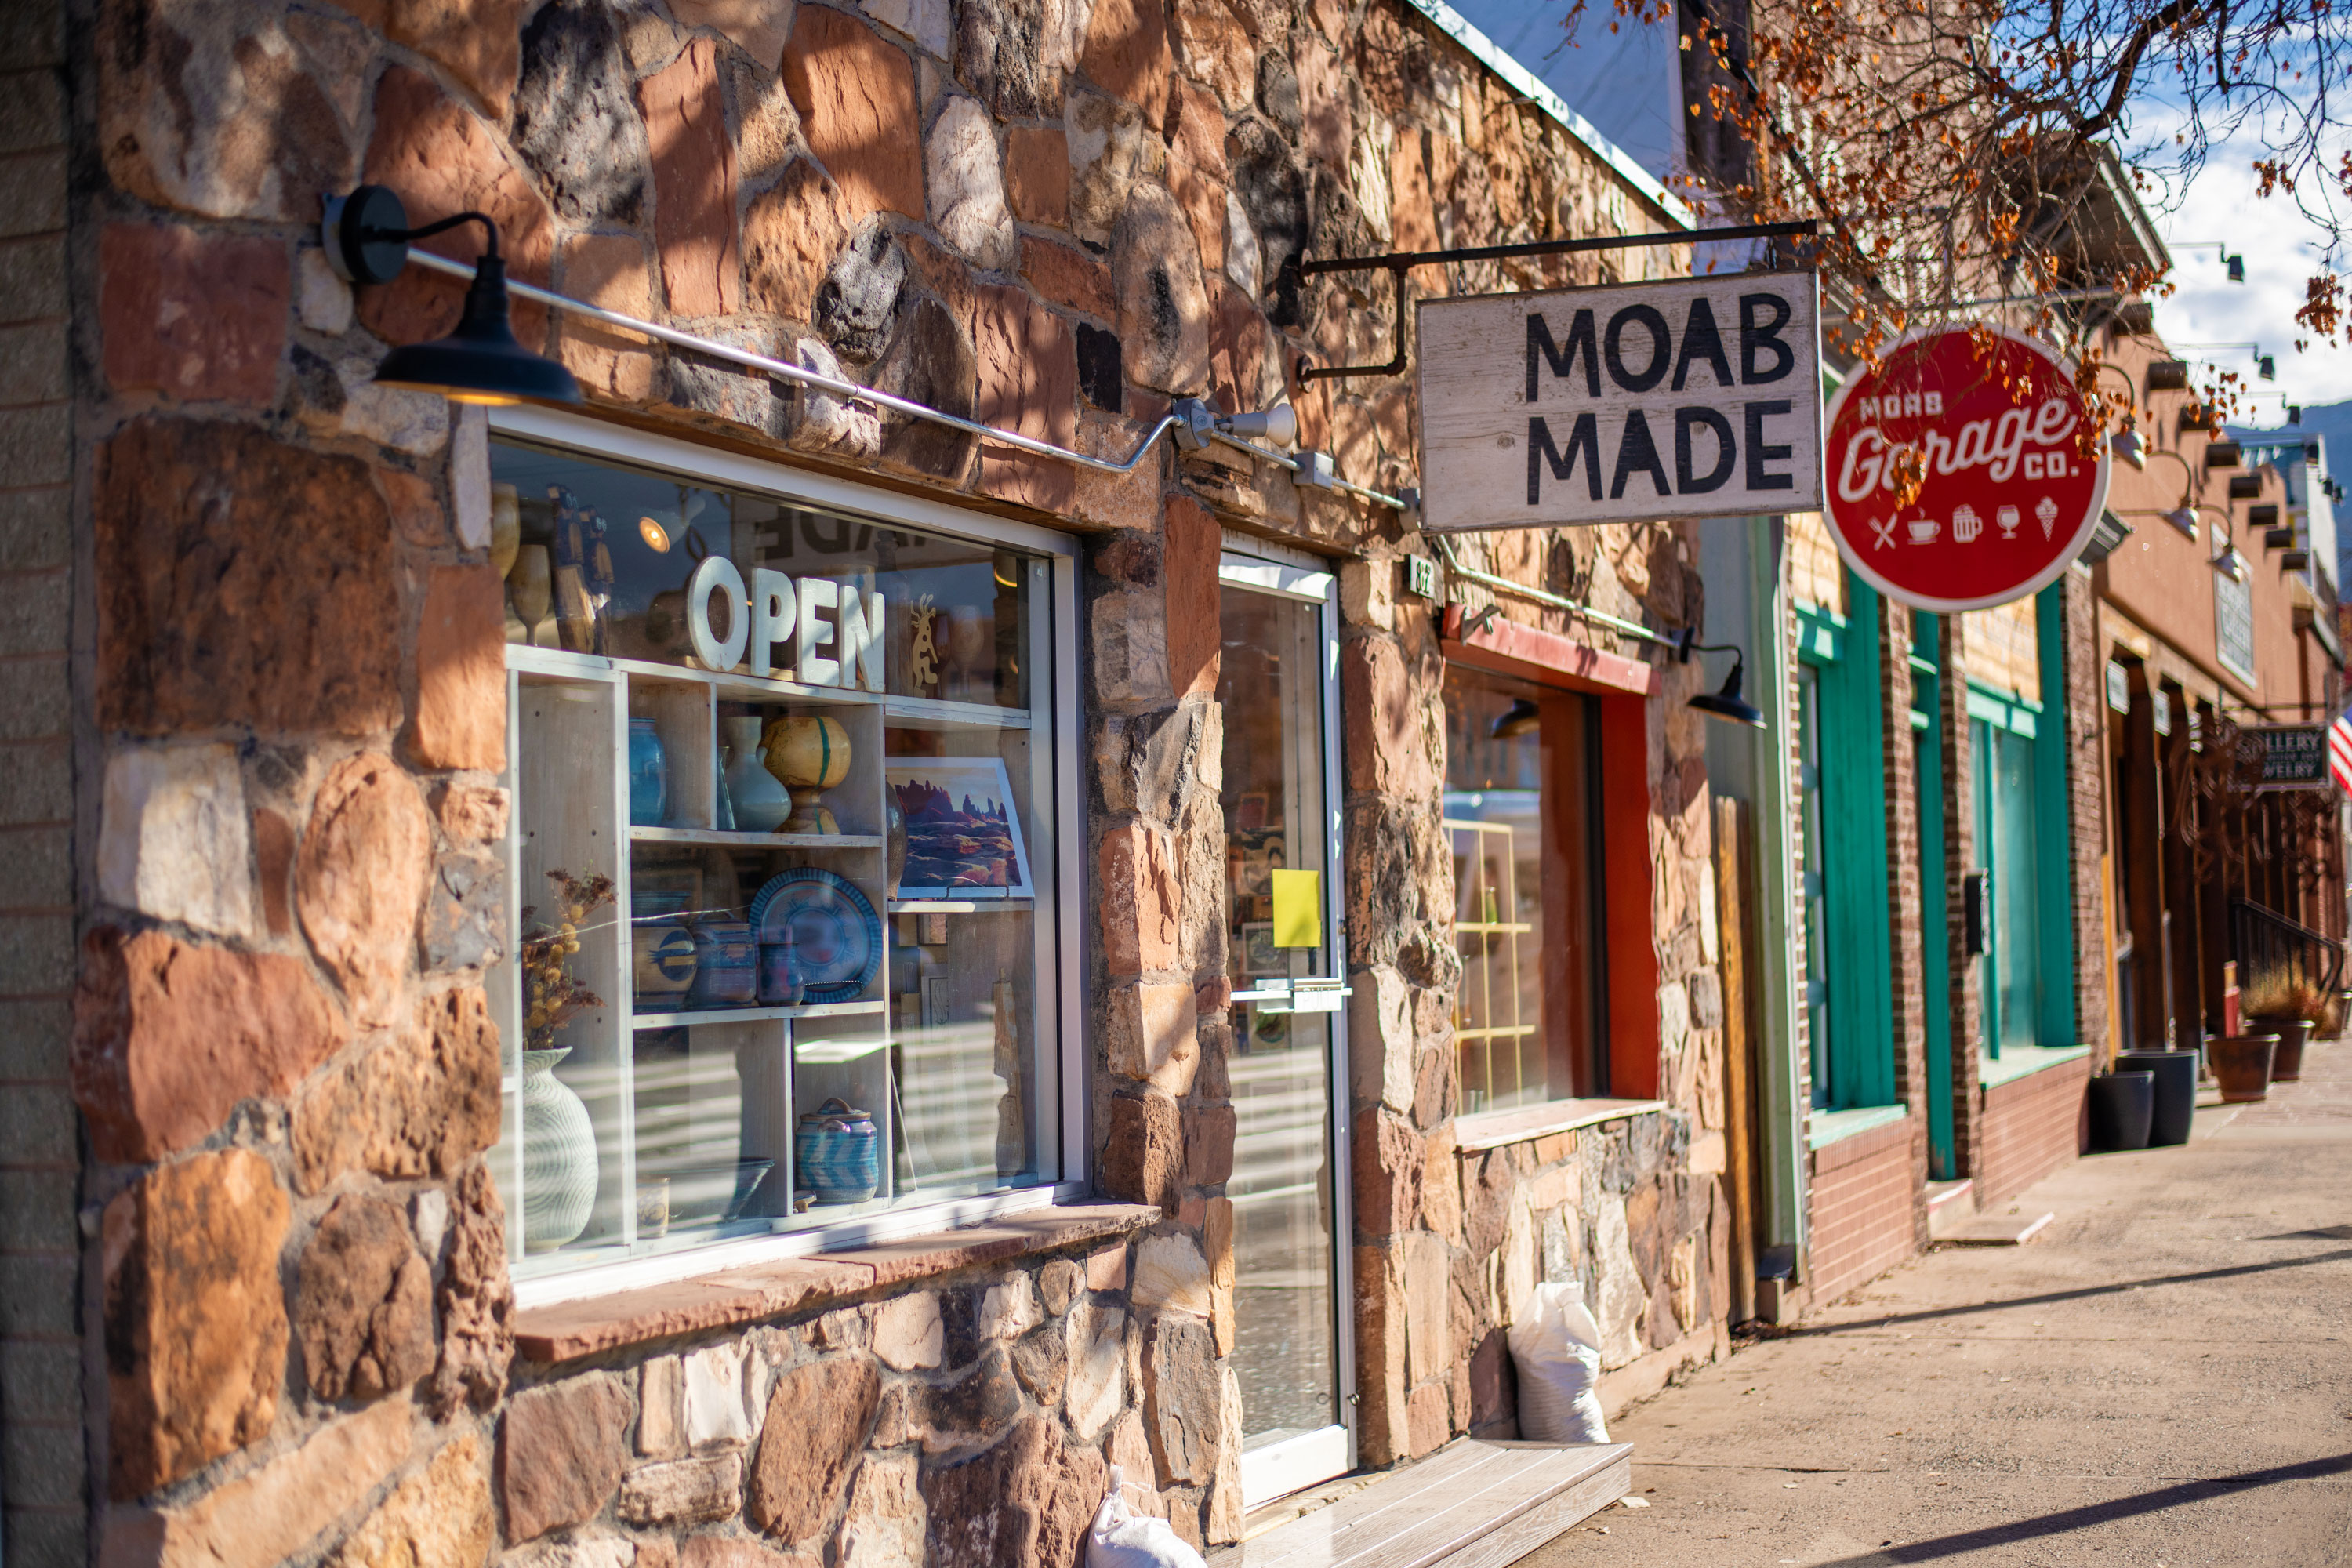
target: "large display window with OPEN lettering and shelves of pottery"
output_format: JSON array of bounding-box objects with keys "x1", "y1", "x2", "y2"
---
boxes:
[{"x1": 492, "y1": 445, "x2": 1058, "y2": 1272}]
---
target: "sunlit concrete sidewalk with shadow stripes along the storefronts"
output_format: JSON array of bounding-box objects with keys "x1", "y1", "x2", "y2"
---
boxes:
[{"x1": 1522, "y1": 1044, "x2": 2352, "y2": 1568}]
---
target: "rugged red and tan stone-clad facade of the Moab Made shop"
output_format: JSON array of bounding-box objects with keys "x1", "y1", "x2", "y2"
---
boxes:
[{"x1": 18, "y1": 0, "x2": 1731, "y2": 1568}]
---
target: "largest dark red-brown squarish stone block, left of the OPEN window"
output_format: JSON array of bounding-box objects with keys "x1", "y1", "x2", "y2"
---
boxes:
[{"x1": 92, "y1": 423, "x2": 400, "y2": 736}]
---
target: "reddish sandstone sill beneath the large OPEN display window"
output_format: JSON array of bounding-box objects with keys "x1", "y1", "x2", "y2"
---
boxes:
[{"x1": 515, "y1": 1203, "x2": 1160, "y2": 1363}]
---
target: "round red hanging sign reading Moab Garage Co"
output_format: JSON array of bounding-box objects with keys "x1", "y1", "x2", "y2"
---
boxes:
[{"x1": 1823, "y1": 327, "x2": 2107, "y2": 612}]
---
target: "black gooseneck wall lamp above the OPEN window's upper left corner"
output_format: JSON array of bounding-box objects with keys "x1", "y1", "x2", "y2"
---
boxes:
[{"x1": 320, "y1": 186, "x2": 581, "y2": 405}]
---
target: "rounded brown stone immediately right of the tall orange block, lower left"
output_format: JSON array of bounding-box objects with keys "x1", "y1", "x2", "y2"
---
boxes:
[{"x1": 294, "y1": 1192, "x2": 433, "y2": 1399}]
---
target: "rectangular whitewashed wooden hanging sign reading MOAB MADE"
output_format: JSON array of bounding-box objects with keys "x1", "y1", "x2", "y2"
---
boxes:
[{"x1": 1416, "y1": 273, "x2": 1820, "y2": 534}]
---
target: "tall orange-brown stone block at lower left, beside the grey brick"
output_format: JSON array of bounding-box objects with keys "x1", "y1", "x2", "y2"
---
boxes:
[{"x1": 101, "y1": 1149, "x2": 289, "y2": 1500}]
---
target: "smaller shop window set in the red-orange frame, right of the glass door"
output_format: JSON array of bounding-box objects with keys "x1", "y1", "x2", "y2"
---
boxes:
[{"x1": 1444, "y1": 666, "x2": 1609, "y2": 1112}]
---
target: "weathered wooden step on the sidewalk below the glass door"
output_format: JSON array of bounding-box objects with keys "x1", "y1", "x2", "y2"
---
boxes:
[{"x1": 1209, "y1": 1439, "x2": 1632, "y2": 1568}]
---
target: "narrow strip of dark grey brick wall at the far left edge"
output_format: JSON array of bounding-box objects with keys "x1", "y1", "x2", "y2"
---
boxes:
[{"x1": 0, "y1": 5, "x2": 87, "y2": 1568}]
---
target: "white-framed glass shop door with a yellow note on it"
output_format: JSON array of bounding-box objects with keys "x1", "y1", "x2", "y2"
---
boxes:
[{"x1": 1216, "y1": 555, "x2": 1355, "y2": 1507}]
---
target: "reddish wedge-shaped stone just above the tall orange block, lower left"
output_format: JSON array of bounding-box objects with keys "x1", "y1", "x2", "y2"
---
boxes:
[{"x1": 73, "y1": 926, "x2": 343, "y2": 1163}]
